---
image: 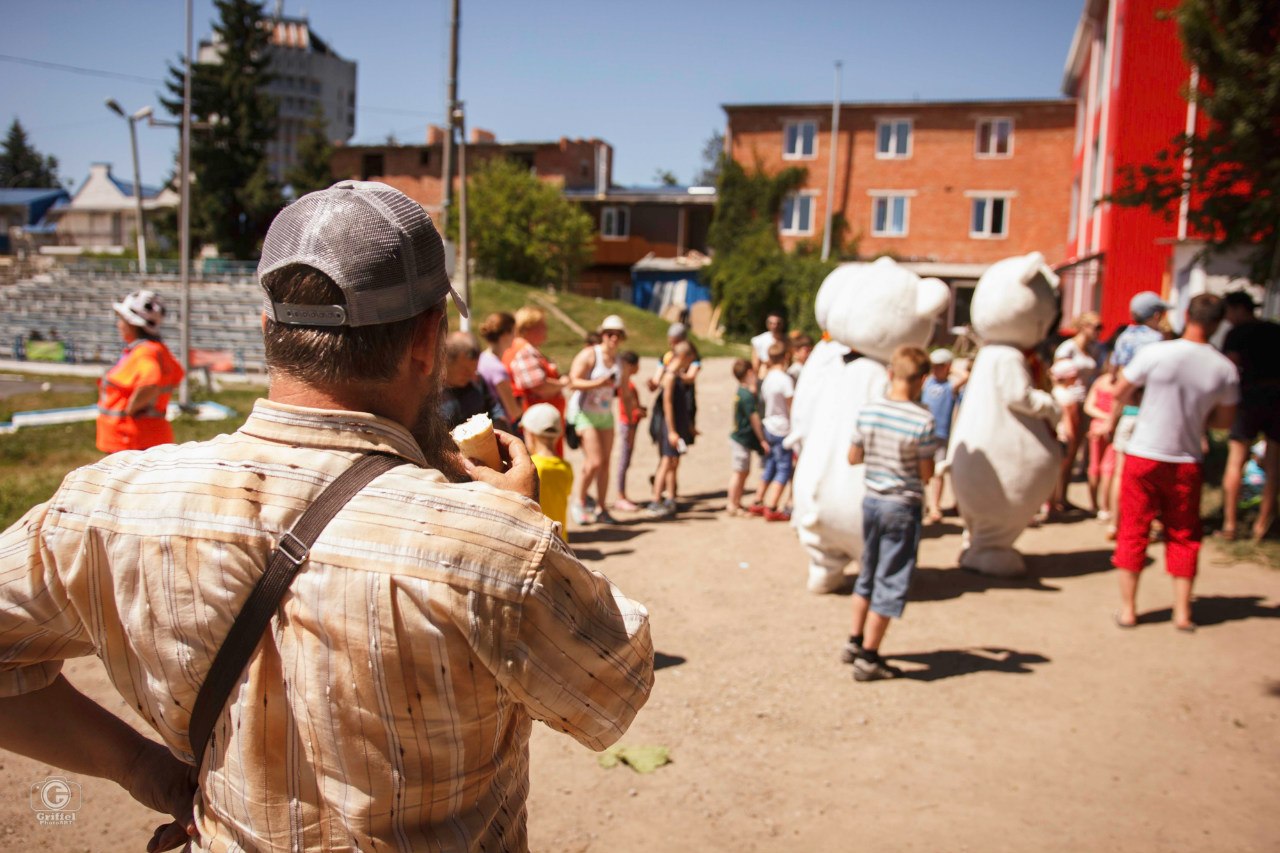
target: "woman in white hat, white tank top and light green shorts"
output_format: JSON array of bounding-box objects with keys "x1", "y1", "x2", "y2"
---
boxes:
[{"x1": 567, "y1": 314, "x2": 627, "y2": 524}]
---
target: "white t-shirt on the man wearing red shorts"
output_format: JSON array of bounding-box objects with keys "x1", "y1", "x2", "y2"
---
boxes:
[{"x1": 1123, "y1": 341, "x2": 1240, "y2": 462}]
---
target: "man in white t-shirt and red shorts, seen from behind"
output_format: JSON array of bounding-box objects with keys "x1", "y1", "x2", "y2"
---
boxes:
[{"x1": 1111, "y1": 293, "x2": 1240, "y2": 631}]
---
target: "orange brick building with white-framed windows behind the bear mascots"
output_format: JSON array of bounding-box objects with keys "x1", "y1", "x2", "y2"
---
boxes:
[{"x1": 723, "y1": 99, "x2": 1075, "y2": 324}]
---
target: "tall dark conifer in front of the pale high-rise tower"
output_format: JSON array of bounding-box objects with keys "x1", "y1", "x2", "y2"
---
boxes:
[{"x1": 161, "y1": 0, "x2": 284, "y2": 259}]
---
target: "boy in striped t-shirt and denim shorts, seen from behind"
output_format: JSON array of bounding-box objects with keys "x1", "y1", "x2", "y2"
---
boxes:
[{"x1": 842, "y1": 347, "x2": 937, "y2": 681}]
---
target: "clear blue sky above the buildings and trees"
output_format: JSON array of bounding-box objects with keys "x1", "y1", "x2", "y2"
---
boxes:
[{"x1": 0, "y1": 0, "x2": 1083, "y2": 186}]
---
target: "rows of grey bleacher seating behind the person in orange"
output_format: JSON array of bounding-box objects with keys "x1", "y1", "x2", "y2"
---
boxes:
[{"x1": 0, "y1": 269, "x2": 264, "y2": 371}]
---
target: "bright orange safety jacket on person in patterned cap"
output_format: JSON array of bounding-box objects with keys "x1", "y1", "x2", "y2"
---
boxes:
[{"x1": 97, "y1": 338, "x2": 183, "y2": 453}]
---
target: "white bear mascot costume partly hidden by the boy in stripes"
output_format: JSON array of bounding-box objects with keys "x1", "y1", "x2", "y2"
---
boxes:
[{"x1": 787, "y1": 257, "x2": 950, "y2": 593}]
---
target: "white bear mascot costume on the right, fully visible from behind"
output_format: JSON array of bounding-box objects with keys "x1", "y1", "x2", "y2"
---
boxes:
[{"x1": 947, "y1": 252, "x2": 1062, "y2": 578}]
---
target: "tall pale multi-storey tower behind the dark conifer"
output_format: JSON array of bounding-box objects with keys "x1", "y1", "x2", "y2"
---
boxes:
[{"x1": 196, "y1": 0, "x2": 356, "y2": 183}]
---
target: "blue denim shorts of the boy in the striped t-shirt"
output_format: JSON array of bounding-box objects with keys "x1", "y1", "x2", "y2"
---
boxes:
[{"x1": 854, "y1": 494, "x2": 920, "y2": 619}]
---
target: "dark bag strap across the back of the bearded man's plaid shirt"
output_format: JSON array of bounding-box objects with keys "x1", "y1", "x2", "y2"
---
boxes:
[{"x1": 188, "y1": 453, "x2": 408, "y2": 768}]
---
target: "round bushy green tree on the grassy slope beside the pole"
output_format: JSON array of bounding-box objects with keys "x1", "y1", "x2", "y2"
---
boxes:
[{"x1": 449, "y1": 158, "x2": 595, "y2": 287}]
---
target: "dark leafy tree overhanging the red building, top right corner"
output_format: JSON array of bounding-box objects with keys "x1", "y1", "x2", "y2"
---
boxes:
[{"x1": 1111, "y1": 0, "x2": 1280, "y2": 283}]
